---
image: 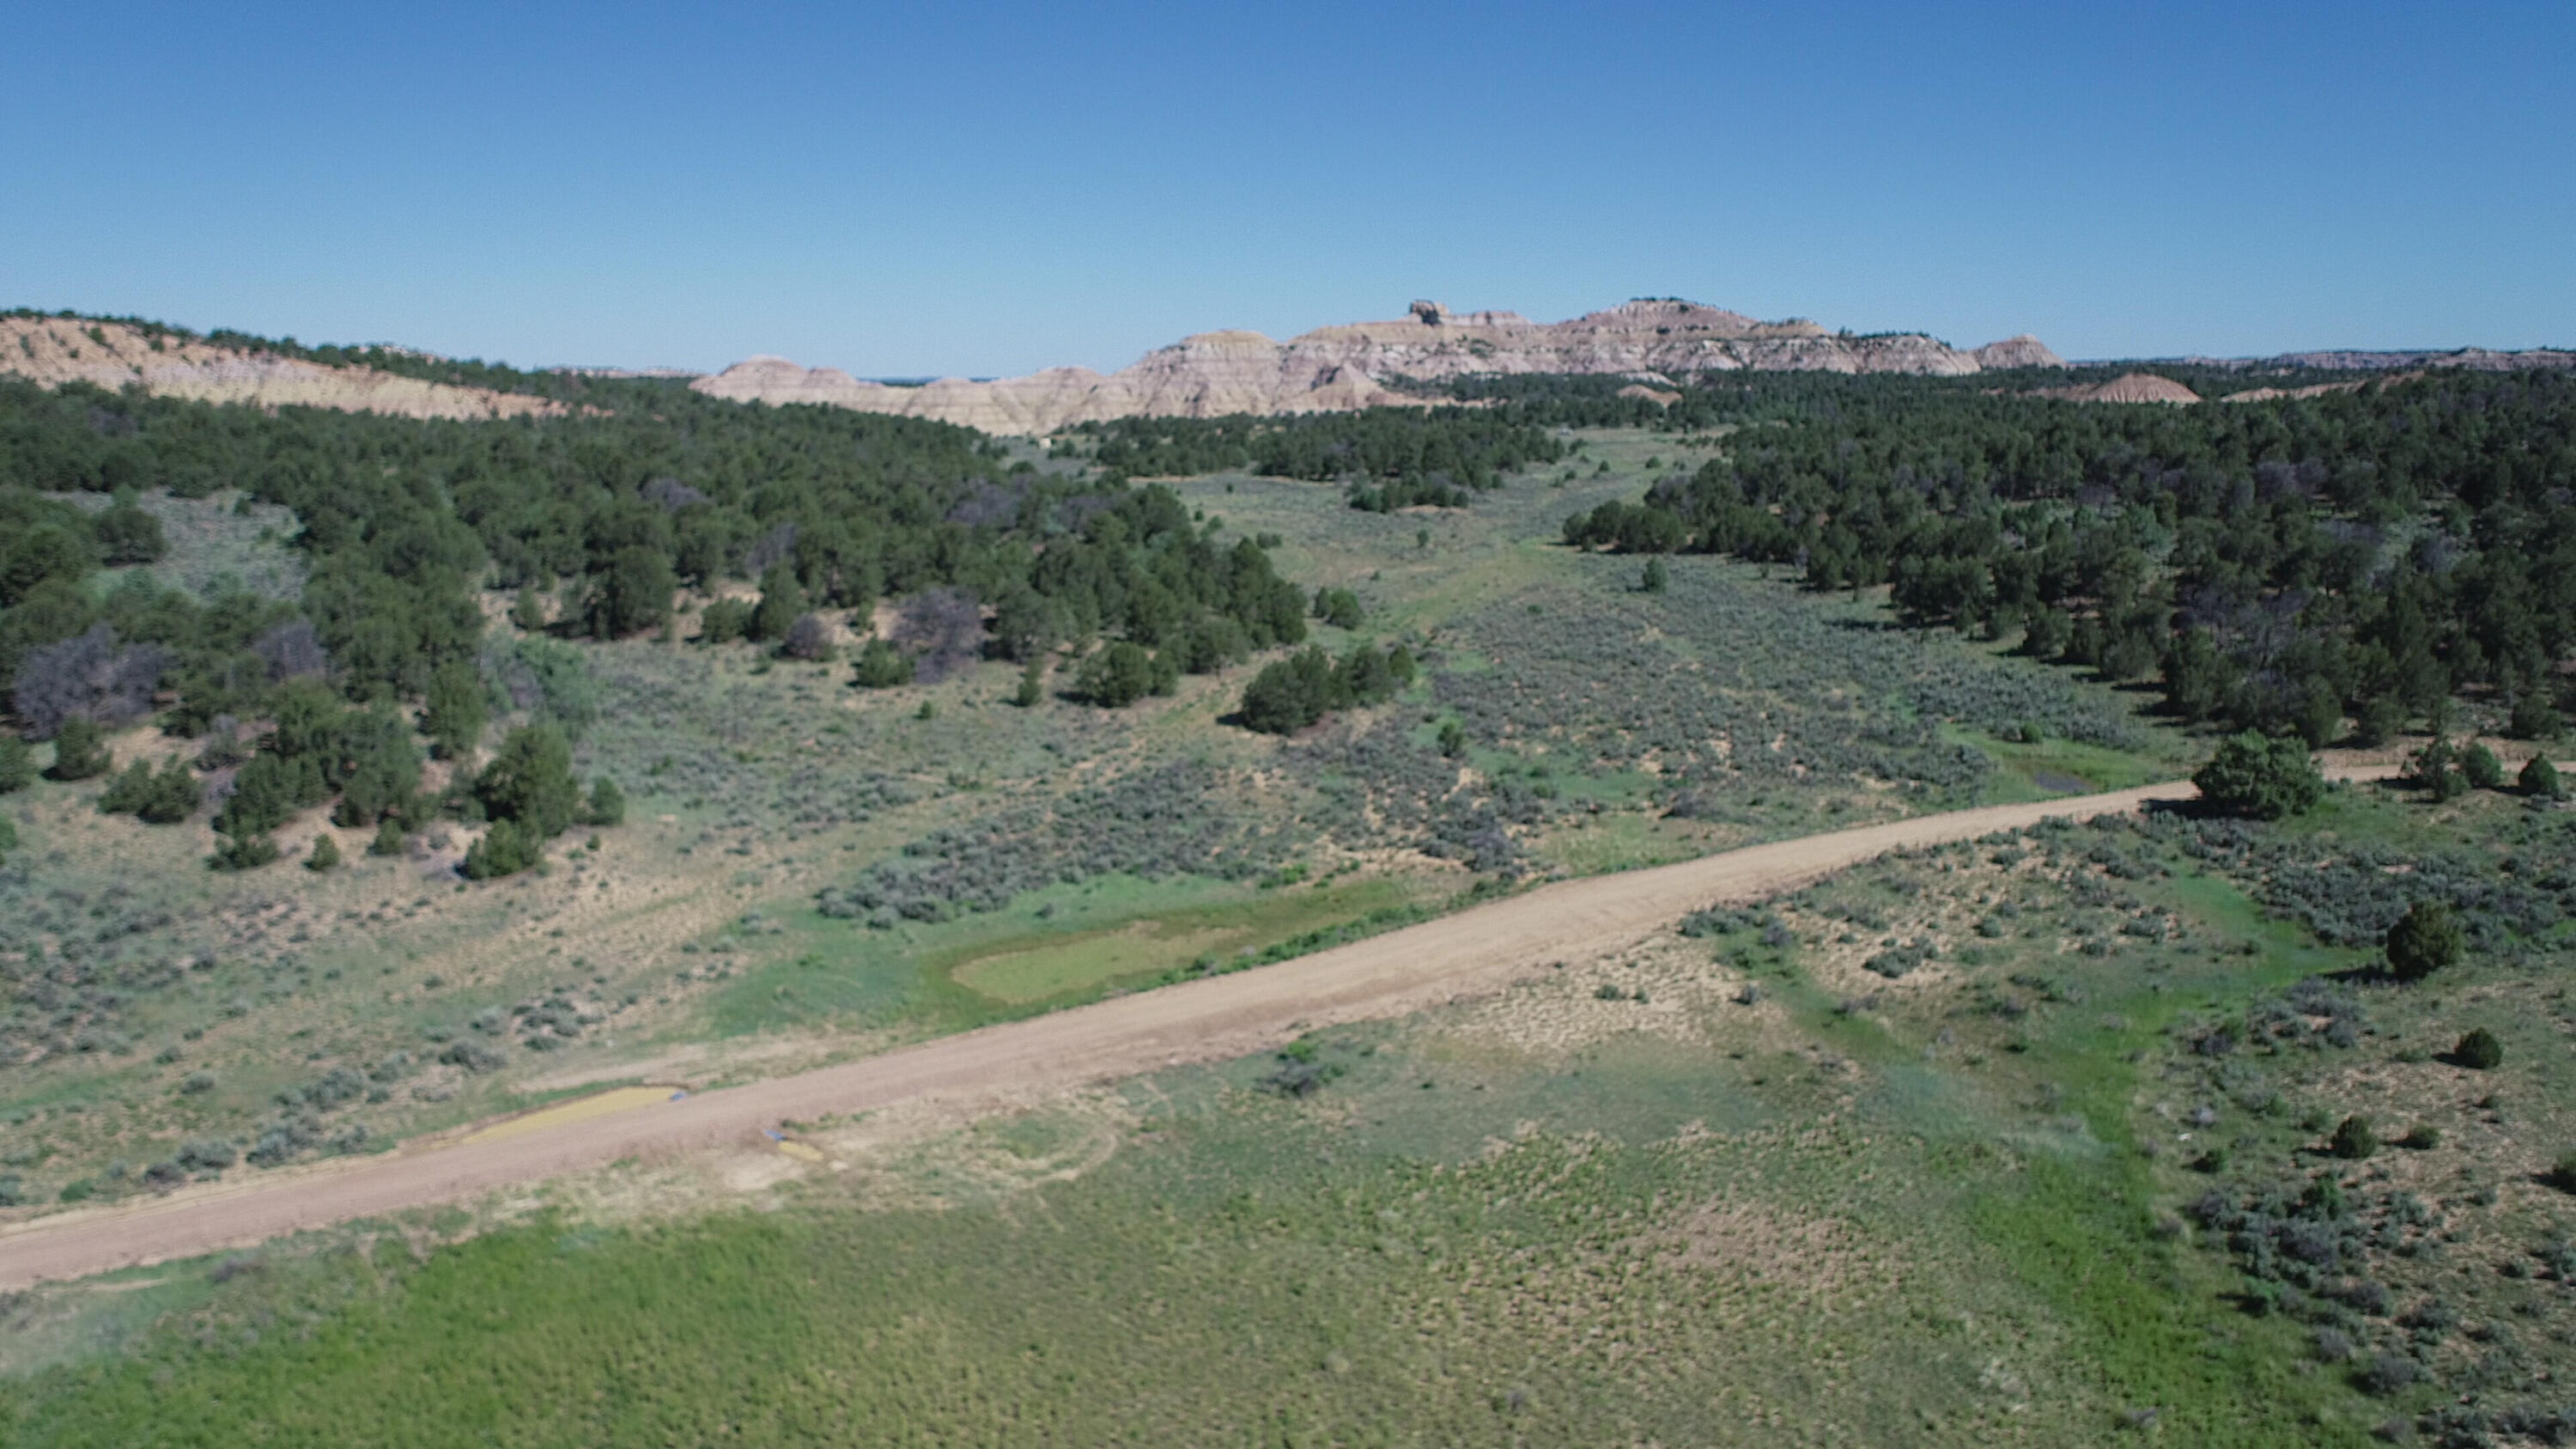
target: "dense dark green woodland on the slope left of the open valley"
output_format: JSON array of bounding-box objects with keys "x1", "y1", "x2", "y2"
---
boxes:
[{"x1": 0, "y1": 314, "x2": 1306, "y2": 763}]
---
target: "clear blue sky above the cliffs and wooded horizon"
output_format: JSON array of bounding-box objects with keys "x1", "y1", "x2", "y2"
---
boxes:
[{"x1": 0, "y1": 0, "x2": 2576, "y2": 376}]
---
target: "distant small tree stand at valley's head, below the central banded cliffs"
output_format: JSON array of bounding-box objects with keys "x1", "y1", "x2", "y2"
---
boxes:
[{"x1": 1069, "y1": 407, "x2": 1566, "y2": 513}]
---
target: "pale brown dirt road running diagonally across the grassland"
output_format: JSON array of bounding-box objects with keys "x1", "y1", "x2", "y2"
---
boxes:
[{"x1": 0, "y1": 771, "x2": 2215, "y2": 1289}]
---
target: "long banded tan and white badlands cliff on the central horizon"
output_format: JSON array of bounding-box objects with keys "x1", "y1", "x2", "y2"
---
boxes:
[{"x1": 690, "y1": 299, "x2": 2066, "y2": 433}]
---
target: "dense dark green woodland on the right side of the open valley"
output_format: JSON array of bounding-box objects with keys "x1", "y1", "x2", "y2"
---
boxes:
[{"x1": 1566, "y1": 371, "x2": 2576, "y2": 746}]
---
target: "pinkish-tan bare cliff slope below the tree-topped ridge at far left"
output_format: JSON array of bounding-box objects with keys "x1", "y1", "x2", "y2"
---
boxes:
[{"x1": 0, "y1": 317, "x2": 564, "y2": 420}]
